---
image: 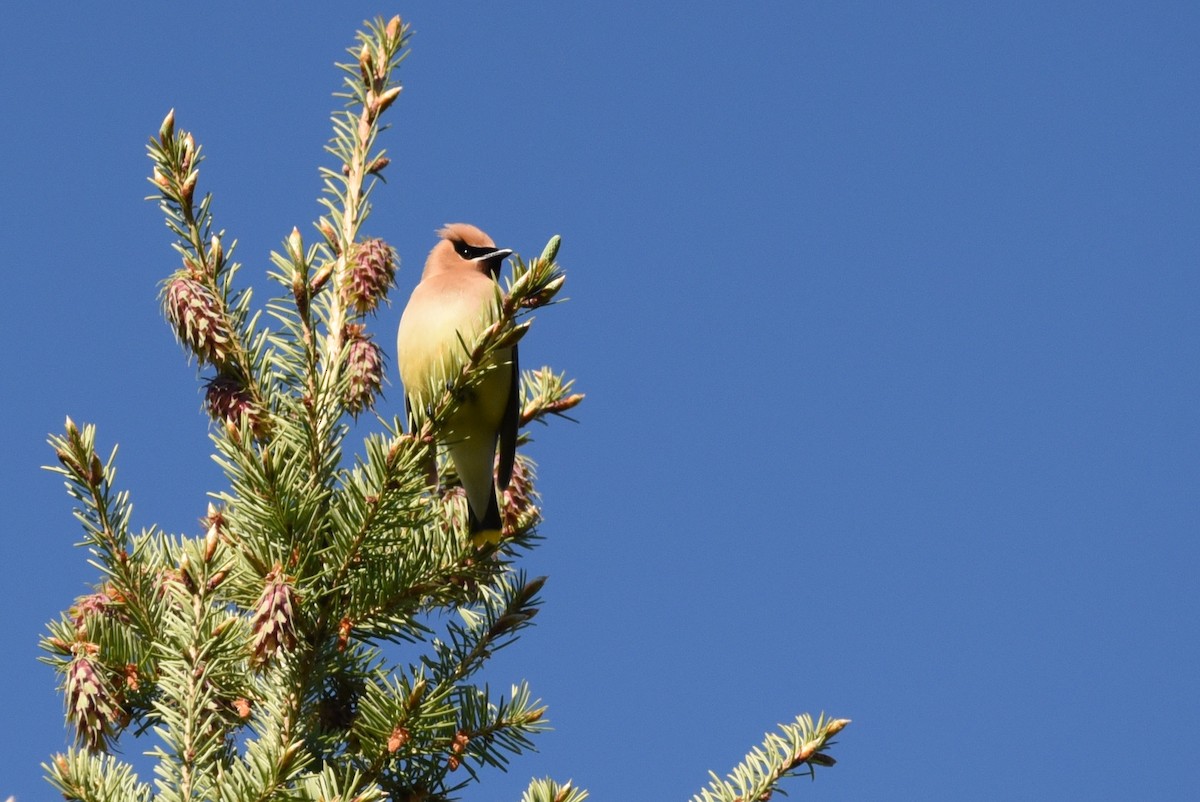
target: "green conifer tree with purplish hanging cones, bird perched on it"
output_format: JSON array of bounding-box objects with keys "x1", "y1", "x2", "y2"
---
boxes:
[{"x1": 42, "y1": 17, "x2": 846, "y2": 802}]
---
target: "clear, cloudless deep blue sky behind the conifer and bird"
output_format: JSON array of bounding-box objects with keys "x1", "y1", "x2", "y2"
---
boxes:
[{"x1": 0, "y1": 0, "x2": 1200, "y2": 802}]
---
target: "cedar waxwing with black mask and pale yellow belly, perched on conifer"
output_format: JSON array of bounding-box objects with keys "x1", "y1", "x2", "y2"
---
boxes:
[{"x1": 396, "y1": 223, "x2": 520, "y2": 545}]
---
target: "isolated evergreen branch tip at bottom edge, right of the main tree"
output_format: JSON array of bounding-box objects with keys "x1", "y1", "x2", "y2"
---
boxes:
[{"x1": 691, "y1": 713, "x2": 850, "y2": 802}]
